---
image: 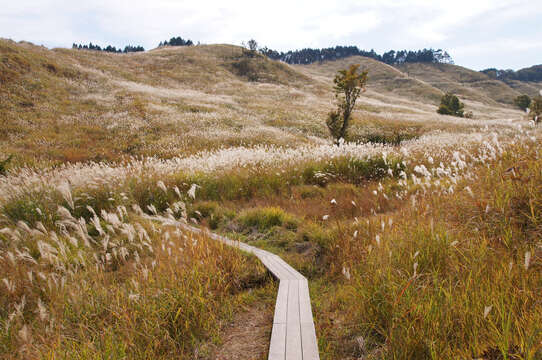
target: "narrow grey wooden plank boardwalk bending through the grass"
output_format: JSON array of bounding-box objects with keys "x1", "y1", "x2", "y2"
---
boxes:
[{"x1": 183, "y1": 225, "x2": 320, "y2": 360}]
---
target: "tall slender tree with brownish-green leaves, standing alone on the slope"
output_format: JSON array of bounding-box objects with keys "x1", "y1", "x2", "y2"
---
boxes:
[{"x1": 326, "y1": 64, "x2": 368, "y2": 146}]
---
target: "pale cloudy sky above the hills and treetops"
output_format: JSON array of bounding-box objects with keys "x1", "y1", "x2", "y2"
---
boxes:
[{"x1": 0, "y1": 0, "x2": 542, "y2": 70}]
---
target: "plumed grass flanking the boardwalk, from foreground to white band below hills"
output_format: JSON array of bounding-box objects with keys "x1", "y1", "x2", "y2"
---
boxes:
[{"x1": 0, "y1": 96, "x2": 541, "y2": 359}]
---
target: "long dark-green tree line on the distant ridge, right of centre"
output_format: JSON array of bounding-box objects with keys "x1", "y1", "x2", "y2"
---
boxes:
[{"x1": 260, "y1": 46, "x2": 454, "y2": 65}]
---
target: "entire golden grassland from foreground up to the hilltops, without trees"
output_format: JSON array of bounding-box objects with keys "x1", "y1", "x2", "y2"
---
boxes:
[{"x1": 0, "y1": 40, "x2": 542, "y2": 360}]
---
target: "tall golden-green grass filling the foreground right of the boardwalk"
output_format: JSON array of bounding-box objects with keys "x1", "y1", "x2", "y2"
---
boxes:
[{"x1": 315, "y1": 142, "x2": 542, "y2": 359}]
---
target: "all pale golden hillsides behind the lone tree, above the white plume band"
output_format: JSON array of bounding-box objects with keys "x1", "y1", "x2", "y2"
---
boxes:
[{"x1": 0, "y1": 40, "x2": 520, "y2": 167}]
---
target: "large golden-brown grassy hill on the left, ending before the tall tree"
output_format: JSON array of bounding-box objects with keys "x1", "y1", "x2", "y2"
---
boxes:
[{"x1": 0, "y1": 40, "x2": 323, "y2": 162}]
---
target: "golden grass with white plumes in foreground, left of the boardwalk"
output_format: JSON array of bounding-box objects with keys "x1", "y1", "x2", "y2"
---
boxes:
[{"x1": 0, "y1": 184, "x2": 269, "y2": 359}]
